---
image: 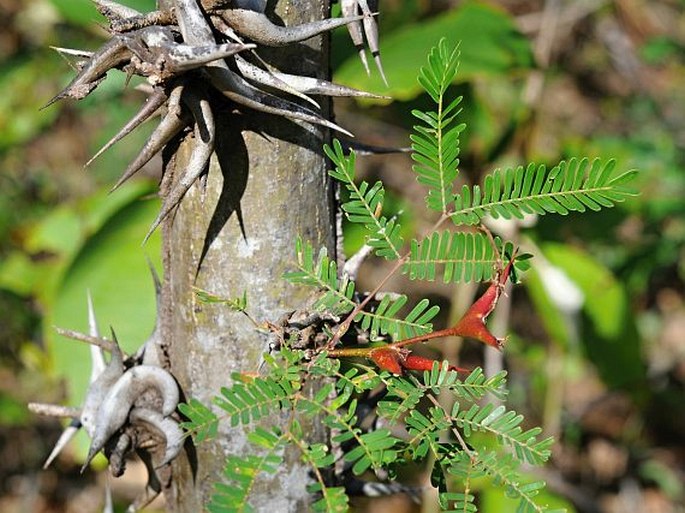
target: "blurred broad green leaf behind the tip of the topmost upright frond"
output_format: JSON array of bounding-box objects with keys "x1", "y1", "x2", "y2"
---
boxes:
[{"x1": 335, "y1": 2, "x2": 533, "y2": 100}]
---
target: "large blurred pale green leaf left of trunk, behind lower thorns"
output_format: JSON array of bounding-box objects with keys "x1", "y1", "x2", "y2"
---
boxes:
[{"x1": 44, "y1": 195, "x2": 160, "y2": 404}]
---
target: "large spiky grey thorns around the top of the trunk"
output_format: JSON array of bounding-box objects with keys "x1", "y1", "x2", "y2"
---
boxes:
[{"x1": 47, "y1": 0, "x2": 385, "y2": 240}]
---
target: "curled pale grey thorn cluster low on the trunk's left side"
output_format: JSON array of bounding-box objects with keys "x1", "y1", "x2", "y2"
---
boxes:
[{"x1": 29, "y1": 269, "x2": 179, "y2": 512}]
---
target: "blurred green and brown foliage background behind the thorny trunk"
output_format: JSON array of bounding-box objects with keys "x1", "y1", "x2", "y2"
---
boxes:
[{"x1": 0, "y1": 0, "x2": 685, "y2": 512}]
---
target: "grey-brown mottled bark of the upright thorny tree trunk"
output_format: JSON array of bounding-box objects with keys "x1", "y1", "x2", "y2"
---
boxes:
[{"x1": 160, "y1": 0, "x2": 335, "y2": 513}]
